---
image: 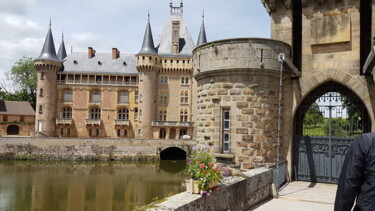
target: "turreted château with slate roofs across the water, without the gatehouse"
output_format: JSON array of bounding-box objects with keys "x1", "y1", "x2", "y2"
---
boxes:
[{"x1": 35, "y1": 2, "x2": 207, "y2": 139}]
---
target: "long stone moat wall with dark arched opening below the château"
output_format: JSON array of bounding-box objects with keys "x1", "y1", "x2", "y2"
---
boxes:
[{"x1": 0, "y1": 137, "x2": 197, "y2": 161}]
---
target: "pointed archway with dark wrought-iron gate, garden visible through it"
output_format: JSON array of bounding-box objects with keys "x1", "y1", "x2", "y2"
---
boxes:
[{"x1": 293, "y1": 81, "x2": 371, "y2": 183}]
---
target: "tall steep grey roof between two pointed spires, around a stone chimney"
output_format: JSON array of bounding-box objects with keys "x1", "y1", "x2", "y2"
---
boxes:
[{"x1": 157, "y1": 13, "x2": 195, "y2": 57}]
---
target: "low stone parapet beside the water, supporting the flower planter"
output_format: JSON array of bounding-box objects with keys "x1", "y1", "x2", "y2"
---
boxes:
[{"x1": 145, "y1": 168, "x2": 273, "y2": 211}]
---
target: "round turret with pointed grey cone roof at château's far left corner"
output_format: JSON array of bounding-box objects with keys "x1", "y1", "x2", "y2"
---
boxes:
[{"x1": 34, "y1": 24, "x2": 62, "y2": 136}]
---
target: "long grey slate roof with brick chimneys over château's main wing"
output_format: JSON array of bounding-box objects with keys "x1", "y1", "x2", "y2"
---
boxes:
[{"x1": 63, "y1": 52, "x2": 138, "y2": 75}]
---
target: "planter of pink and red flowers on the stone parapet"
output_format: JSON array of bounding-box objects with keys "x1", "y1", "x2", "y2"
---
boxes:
[{"x1": 186, "y1": 145, "x2": 223, "y2": 194}]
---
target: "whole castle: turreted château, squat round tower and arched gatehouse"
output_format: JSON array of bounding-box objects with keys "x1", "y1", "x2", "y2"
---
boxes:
[{"x1": 35, "y1": 0, "x2": 375, "y2": 183}]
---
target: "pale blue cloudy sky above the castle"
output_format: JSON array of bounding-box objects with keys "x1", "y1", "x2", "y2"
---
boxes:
[{"x1": 0, "y1": 0, "x2": 270, "y2": 83}]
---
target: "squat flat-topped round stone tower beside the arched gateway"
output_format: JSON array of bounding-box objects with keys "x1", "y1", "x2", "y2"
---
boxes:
[{"x1": 193, "y1": 38, "x2": 291, "y2": 169}]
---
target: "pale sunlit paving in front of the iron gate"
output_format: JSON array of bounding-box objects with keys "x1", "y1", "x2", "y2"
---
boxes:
[{"x1": 249, "y1": 182, "x2": 337, "y2": 211}]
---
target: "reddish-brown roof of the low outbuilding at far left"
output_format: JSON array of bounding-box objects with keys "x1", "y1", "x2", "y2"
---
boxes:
[{"x1": 0, "y1": 101, "x2": 35, "y2": 116}]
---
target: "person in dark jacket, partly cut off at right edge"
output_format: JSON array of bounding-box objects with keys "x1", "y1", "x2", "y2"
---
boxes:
[{"x1": 335, "y1": 133, "x2": 375, "y2": 211}]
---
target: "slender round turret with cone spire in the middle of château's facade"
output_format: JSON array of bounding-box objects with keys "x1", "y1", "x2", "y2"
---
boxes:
[{"x1": 135, "y1": 19, "x2": 161, "y2": 138}]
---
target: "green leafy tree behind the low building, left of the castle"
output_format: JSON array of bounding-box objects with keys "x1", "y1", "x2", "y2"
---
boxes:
[{"x1": 0, "y1": 56, "x2": 37, "y2": 109}]
